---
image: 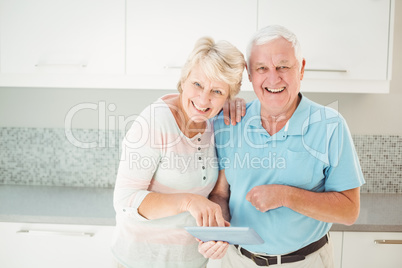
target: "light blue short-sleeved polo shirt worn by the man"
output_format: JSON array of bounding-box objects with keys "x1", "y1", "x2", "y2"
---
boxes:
[{"x1": 214, "y1": 95, "x2": 364, "y2": 254}]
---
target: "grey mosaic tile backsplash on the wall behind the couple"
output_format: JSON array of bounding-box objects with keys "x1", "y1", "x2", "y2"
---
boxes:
[{"x1": 0, "y1": 128, "x2": 402, "y2": 194}]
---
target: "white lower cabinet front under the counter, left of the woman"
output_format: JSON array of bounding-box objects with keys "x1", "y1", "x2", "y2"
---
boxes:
[{"x1": 0, "y1": 222, "x2": 116, "y2": 268}]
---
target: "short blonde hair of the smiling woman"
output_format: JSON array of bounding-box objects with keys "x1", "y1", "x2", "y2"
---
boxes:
[{"x1": 177, "y1": 37, "x2": 245, "y2": 98}]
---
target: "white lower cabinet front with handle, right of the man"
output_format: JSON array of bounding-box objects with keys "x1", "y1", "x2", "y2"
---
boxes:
[{"x1": 342, "y1": 232, "x2": 402, "y2": 268}]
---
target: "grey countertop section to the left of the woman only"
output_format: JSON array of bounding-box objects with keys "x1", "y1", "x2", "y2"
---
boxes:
[{"x1": 0, "y1": 185, "x2": 115, "y2": 225}]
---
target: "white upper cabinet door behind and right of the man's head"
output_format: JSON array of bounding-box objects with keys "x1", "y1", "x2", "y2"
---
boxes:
[{"x1": 258, "y1": 0, "x2": 394, "y2": 93}]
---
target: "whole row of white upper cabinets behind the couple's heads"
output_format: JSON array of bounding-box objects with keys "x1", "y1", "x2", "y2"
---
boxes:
[{"x1": 0, "y1": 0, "x2": 395, "y2": 93}]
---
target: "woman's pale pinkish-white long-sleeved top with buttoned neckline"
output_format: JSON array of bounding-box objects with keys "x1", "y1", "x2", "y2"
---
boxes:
[{"x1": 112, "y1": 95, "x2": 218, "y2": 268}]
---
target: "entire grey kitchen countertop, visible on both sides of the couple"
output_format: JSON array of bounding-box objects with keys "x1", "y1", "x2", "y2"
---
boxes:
[{"x1": 0, "y1": 185, "x2": 402, "y2": 232}]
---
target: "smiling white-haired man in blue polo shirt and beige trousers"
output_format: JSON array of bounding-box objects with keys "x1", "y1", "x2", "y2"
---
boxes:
[{"x1": 199, "y1": 25, "x2": 364, "y2": 268}]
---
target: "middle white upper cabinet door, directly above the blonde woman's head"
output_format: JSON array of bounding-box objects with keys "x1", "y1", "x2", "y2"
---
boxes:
[{"x1": 127, "y1": 0, "x2": 257, "y2": 89}]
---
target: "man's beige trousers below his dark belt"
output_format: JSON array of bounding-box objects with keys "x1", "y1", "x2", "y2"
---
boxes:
[{"x1": 222, "y1": 239, "x2": 334, "y2": 268}]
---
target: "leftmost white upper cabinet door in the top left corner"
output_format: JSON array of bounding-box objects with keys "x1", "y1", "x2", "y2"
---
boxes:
[{"x1": 0, "y1": 0, "x2": 125, "y2": 74}]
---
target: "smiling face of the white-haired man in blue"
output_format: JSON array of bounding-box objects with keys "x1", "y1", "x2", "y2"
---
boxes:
[{"x1": 247, "y1": 38, "x2": 305, "y2": 115}]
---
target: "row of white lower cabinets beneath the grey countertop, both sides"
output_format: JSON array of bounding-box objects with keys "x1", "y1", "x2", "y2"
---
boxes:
[{"x1": 5, "y1": 222, "x2": 402, "y2": 268}]
